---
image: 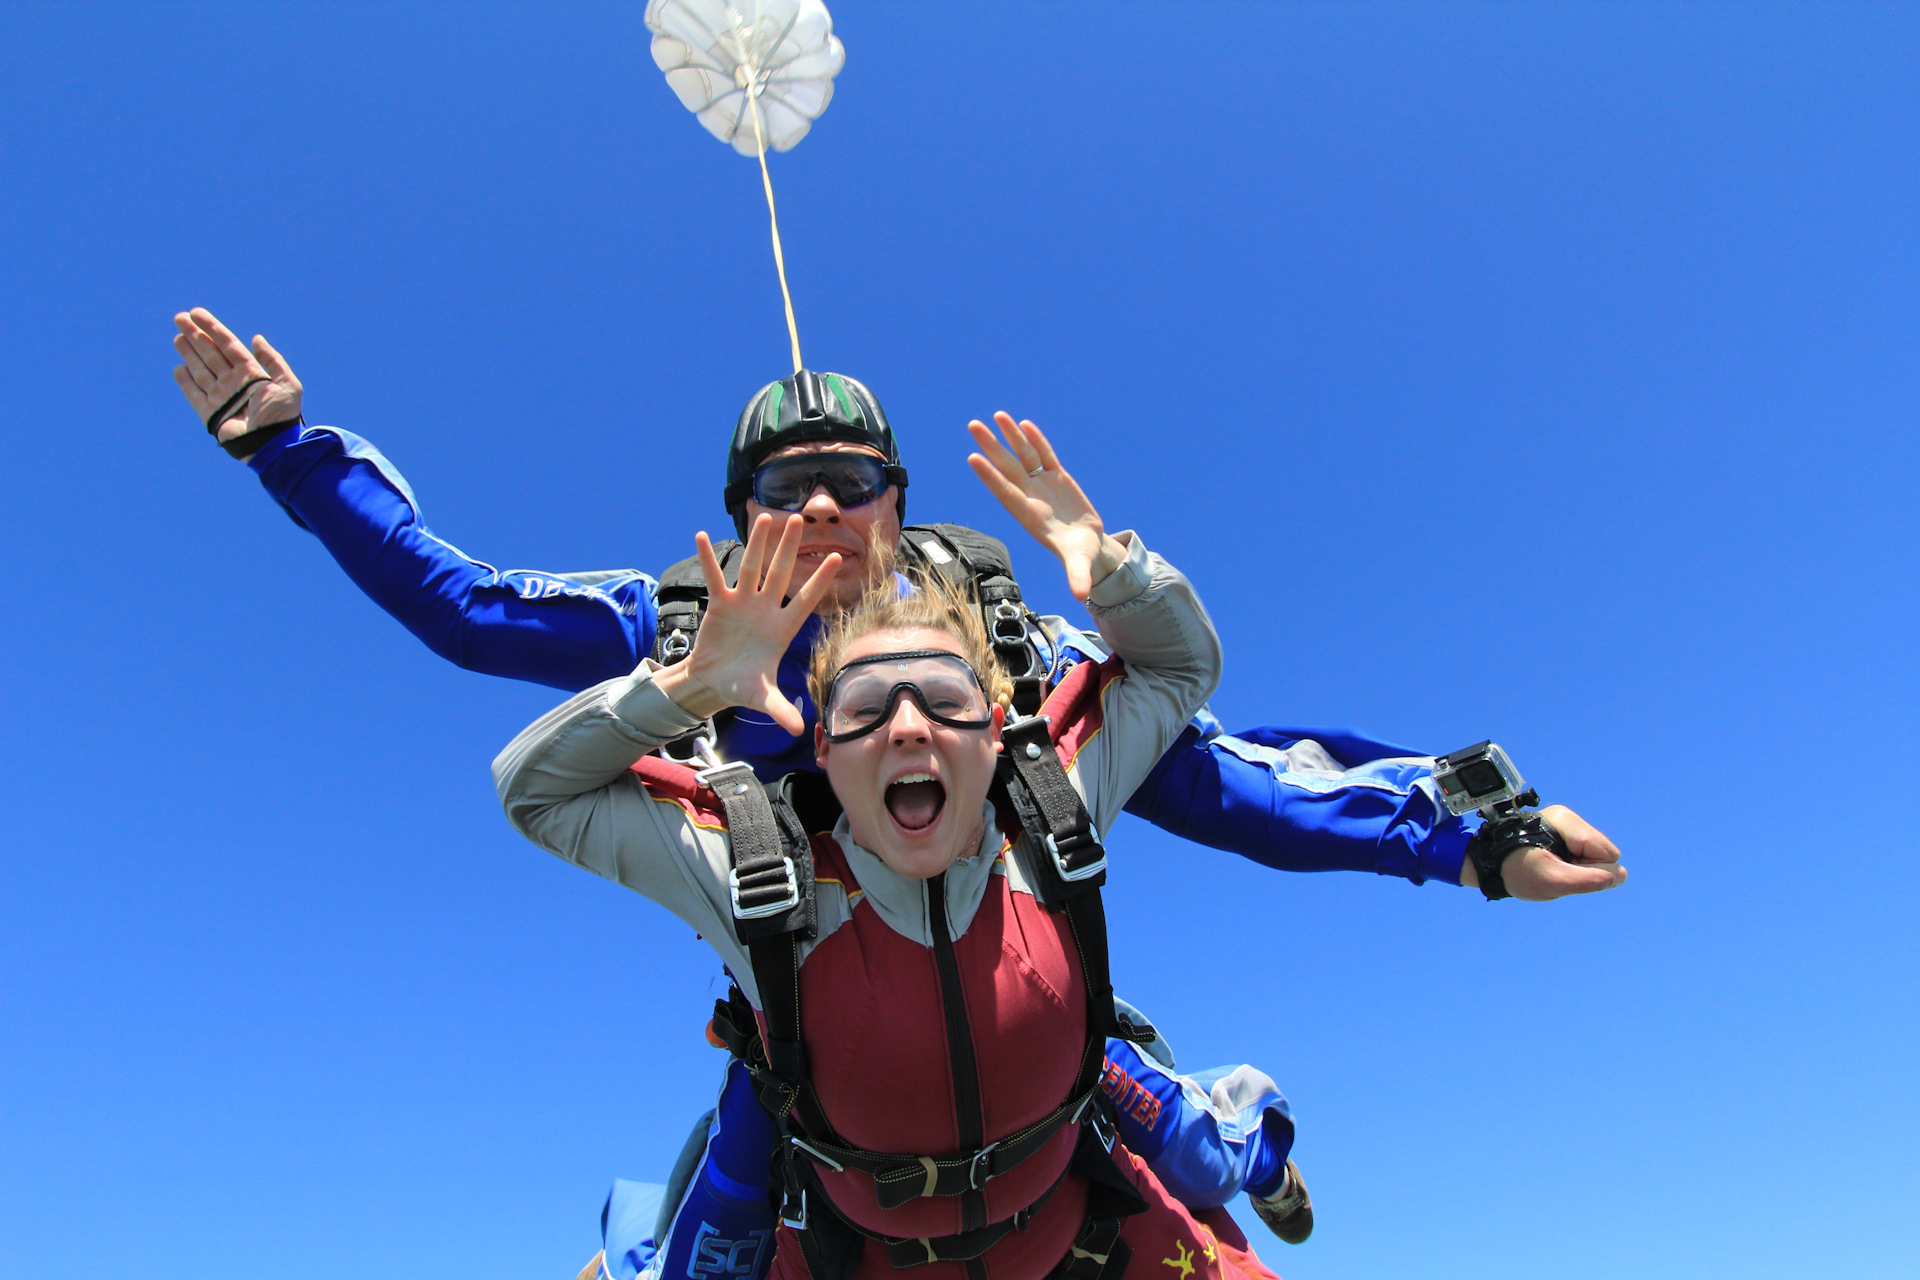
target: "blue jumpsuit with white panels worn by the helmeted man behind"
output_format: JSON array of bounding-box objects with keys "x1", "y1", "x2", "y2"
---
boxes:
[{"x1": 250, "y1": 426, "x2": 1473, "y2": 1280}]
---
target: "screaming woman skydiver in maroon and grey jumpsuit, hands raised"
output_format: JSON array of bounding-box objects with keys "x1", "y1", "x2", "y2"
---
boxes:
[{"x1": 493, "y1": 415, "x2": 1271, "y2": 1280}]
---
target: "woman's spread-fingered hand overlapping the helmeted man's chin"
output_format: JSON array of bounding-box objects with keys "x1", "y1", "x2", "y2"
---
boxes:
[{"x1": 655, "y1": 514, "x2": 839, "y2": 737}]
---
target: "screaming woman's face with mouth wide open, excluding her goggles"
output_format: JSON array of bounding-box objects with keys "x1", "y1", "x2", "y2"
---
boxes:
[{"x1": 814, "y1": 628, "x2": 1004, "y2": 881}]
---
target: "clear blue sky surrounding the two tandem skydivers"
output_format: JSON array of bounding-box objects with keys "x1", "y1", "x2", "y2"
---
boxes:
[{"x1": 0, "y1": 0, "x2": 1920, "y2": 1280}]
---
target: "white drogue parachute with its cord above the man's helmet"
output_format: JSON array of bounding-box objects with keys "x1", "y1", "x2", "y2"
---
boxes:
[{"x1": 647, "y1": 0, "x2": 847, "y2": 372}]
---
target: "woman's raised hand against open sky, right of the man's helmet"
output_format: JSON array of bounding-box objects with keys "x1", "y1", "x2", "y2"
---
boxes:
[{"x1": 966, "y1": 413, "x2": 1127, "y2": 601}]
